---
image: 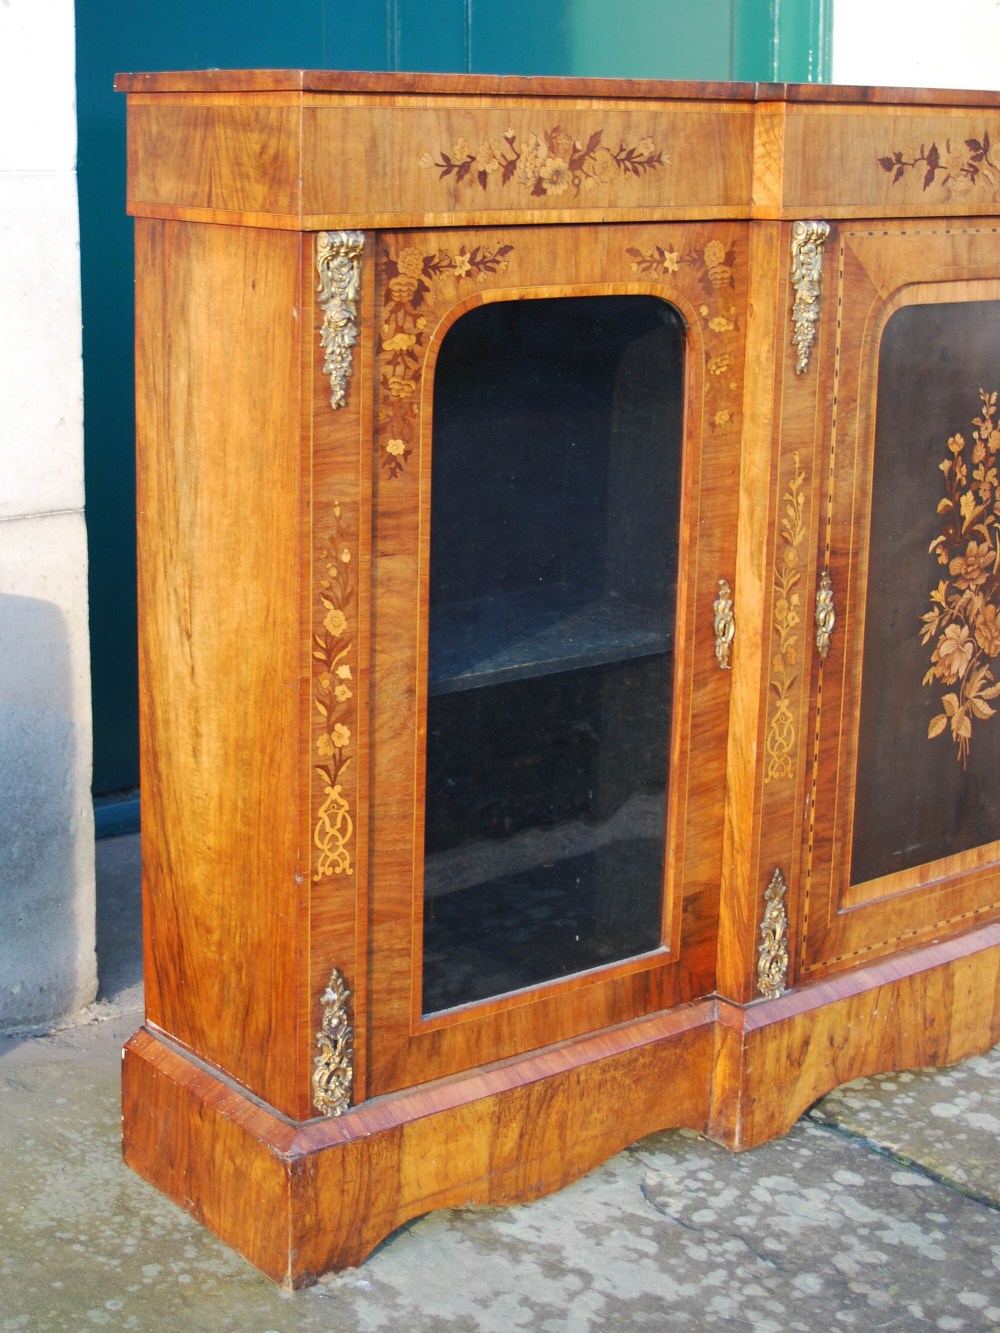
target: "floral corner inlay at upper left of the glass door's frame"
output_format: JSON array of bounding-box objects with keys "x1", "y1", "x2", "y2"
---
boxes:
[{"x1": 379, "y1": 245, "x2": 513, "y2": 477}]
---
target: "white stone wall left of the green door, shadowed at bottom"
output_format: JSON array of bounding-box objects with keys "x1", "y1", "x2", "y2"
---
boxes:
[{"x1": 0, "y1": 0, "x2": 96, "y2": 1030}]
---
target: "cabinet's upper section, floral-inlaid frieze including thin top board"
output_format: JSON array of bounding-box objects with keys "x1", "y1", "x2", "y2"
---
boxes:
[{"x1": 116, "y1": 69, "x2": 1000, "y2": 223}]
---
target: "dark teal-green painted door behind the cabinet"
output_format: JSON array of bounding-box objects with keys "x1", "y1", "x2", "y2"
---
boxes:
[{"x1": 76, "y1": 0, "x2": 832, "y2": 832}]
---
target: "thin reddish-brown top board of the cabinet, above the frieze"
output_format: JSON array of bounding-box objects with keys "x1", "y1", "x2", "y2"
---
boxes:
[{"x1": 115, "y1": 69, "x2": 1000, "y2": 107}]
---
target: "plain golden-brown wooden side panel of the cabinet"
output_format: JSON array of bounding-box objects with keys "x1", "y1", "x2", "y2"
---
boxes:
[{"x1": 136, "y1": 215, "x2": 308, "y2": 1114}]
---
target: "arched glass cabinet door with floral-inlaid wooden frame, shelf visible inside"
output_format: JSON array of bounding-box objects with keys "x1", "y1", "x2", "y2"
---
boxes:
[{"x1": 367, "y1": 215, "x2": 747, "y2": 1093}]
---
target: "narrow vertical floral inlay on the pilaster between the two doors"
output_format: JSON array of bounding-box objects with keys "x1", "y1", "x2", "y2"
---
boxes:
[{"x1": 764, "y1": 453, "x2": 805, "y2": 785}]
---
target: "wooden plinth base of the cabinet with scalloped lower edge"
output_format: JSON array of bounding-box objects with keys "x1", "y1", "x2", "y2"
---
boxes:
[{"x1": 123, "y1": 924, "x2": 1000, "y2": 1286}]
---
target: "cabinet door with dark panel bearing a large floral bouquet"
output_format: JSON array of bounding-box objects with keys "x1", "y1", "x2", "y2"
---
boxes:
[{"x1": 800, "y1": 219, "x2": 1000, "y2": 980}]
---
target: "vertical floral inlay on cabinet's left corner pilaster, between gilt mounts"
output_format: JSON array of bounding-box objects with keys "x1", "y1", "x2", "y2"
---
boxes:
[{"x1": 312, "y1": 500, "x2": 357, "y2": 881}]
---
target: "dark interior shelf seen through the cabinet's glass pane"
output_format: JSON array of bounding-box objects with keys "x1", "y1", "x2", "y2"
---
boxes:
[{"x1": 428, "y1": 584, "x2": 671, "y2": 694}]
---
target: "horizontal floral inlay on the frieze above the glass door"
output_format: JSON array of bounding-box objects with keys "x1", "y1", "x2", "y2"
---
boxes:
[{"x1": 420, "y1": 125, "x2": 669, "y2": 199}]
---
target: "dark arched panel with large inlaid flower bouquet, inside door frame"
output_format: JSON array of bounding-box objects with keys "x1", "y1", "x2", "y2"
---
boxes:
[{"x1": 851, "y1": 301, "x2": 1000, "y2": 884}]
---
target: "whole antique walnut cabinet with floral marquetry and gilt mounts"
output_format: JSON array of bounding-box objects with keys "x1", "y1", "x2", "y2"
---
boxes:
[{"x1": 119, "y1": 71, "x2": 1000, "y2": 1285}]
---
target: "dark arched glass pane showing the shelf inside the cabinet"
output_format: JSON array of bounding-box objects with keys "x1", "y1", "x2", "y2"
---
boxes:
[{"x1": 424, "y1": 296, "x2": 684, "y2": 1013}]
